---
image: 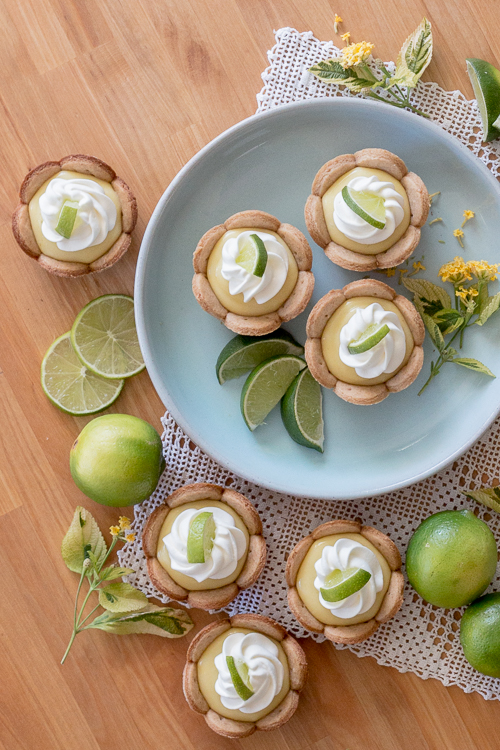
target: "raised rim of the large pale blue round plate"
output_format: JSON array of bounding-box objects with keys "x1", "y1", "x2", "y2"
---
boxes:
[{"x1": 134, "y1": 97, "x2": 500, "y2": 500}]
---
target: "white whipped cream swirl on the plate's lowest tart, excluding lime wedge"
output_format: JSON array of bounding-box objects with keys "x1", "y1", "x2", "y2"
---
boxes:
[{"x1": 339, "y1": 302, "x2": 406, "y2": 378}]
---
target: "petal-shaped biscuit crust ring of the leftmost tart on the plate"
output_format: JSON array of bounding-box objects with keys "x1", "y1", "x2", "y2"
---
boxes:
[{"x1": 192, "y1": 211, "x2": 314, "y2": 336}]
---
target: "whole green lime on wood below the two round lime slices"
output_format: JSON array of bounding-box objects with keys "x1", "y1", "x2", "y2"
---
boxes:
[{"x1": 69, "y1": 414, "x2": 165, "y2": 507}]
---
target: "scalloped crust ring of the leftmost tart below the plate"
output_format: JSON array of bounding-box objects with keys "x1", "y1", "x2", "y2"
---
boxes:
[{"x1": 142, "y1": 482, "x2": 267, "y2": 610}]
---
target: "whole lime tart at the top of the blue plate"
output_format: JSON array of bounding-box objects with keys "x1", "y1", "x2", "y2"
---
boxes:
[{"x1": 305, "y1": 148, "x2": 429, "y2": 271}]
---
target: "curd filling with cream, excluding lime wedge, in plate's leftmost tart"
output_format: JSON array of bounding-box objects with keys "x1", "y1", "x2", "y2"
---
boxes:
[{"x1": 207, "y1": 227, "x2": 298, "y2": 317}]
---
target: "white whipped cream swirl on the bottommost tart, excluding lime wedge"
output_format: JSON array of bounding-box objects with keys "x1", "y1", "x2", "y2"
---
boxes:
[{"x1": 215, "y1": 633, "x2": 284, "y2": 714}]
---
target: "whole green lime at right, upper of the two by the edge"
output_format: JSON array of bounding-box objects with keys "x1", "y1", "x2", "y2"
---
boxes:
[{"x1": 406, "y1": 510, "x2": 497, "y2": 607}]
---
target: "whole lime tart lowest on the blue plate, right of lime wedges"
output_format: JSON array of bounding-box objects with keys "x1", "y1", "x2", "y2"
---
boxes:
[{"x1": 305, "y1": 279, "x2": 425, "y2": 406}]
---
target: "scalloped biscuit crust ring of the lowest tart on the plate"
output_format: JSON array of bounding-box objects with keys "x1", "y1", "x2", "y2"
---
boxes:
[{"x1": 305, "y1": 279, "x2": 425, "y2": 406}]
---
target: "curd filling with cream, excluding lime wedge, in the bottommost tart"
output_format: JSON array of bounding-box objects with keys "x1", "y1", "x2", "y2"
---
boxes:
[{"x1": 197, "y1": 628, "x2": 290, "y2": 721}]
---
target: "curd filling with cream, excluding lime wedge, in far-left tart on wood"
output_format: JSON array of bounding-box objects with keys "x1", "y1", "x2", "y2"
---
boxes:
[{"x1": 29, "y1": 171, "x2": 122, "y2": 263}]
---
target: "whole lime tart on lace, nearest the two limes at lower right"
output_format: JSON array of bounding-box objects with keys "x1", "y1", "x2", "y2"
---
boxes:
[{"x1": 285, "y1": 519, "x2": 404, "y2": 644}]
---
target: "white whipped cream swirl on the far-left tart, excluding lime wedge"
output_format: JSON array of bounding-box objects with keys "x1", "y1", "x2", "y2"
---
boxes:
[{"x1": 39, "y1": 177, "x2": 117, "y2": 253}]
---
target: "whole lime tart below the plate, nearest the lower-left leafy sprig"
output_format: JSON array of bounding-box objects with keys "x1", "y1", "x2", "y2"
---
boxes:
[{"x1": 142, "y1": 482, "x2": 266, "y2": 609}]
